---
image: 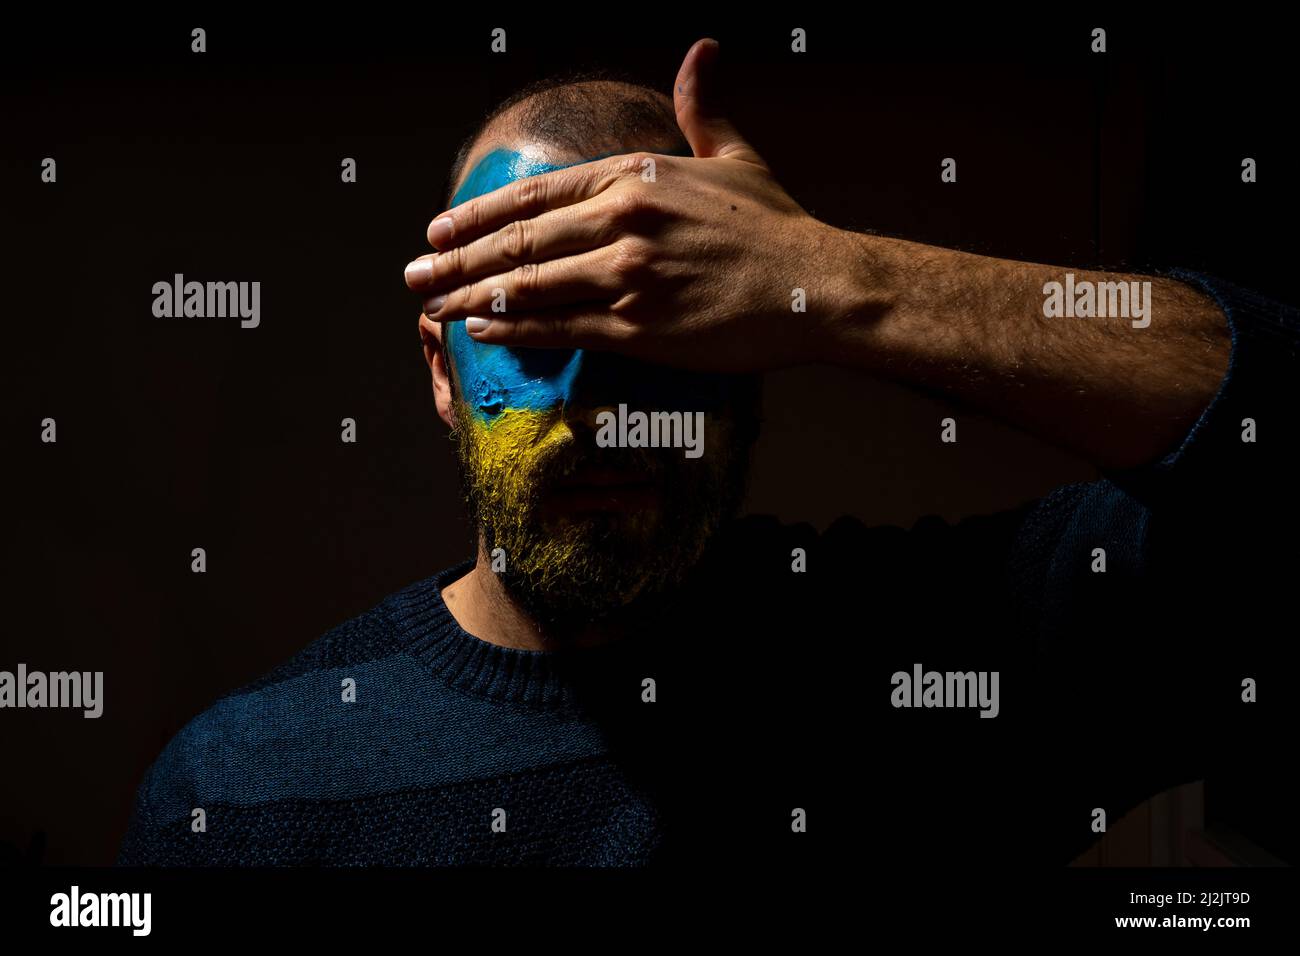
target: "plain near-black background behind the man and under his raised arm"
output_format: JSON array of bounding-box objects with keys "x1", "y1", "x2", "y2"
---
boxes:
[{"x1": 0, "y1": 13, "x2": 1296, "y2": 864}]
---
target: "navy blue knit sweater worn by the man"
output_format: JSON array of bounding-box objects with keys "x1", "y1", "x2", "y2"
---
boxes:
[{"x1": 118, "y1": 272, "x2": 1300, "y2": 866}]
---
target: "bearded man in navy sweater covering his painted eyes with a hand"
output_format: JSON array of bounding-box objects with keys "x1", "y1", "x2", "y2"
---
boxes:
[{"x1": 120, "y1": 43, "x2": 1297, "y2": 868}]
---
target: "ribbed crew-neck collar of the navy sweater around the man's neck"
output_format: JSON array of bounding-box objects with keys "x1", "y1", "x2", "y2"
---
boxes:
[{"x1": 384, "y1": 558, "x2": 660, "y2": 709}]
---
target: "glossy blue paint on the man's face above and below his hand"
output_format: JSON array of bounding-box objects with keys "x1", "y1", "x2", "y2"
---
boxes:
[{"x1": 447, "y1": 150, "x2": 732, "y2": 423}]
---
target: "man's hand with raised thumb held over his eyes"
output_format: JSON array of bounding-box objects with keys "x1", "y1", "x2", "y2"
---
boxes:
[{"x1": 397, "y1": 40, "x2": 857, "y2": 372}]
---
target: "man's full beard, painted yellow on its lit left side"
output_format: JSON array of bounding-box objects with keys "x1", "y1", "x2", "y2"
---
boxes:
[{"x1": 452, "y1": 397, "x2": 758, "y2": 630}]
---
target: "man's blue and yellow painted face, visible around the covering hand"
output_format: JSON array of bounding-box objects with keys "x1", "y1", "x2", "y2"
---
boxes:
[{"x1": 445, "y1": 140, "x2": 753, "y2": 620}]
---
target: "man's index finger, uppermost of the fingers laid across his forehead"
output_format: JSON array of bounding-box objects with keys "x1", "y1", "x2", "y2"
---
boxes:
[{"x1": 426, "y1": 152, "x2": 668, "y2": 252}]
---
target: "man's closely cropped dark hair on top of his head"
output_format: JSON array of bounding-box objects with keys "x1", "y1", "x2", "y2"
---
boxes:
[{"x1": 445, "y1": 69, "x2": 689, "y2": 206}]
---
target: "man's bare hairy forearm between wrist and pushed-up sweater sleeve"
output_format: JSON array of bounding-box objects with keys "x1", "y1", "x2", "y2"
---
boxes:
[{"x1": 822, "y1": 230, "x2": 1230, "y2": 468}]
